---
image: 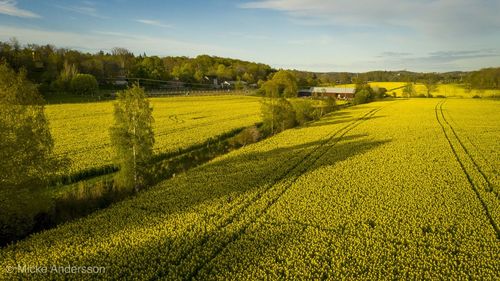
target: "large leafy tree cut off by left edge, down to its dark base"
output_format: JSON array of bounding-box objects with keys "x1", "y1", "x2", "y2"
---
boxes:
[{"x1": 0, "y1": 63, "x2": 62, "y2": 244}]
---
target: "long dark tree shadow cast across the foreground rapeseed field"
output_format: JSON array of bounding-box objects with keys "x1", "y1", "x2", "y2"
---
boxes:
[{"x1": 0, "y1": 115, "x2": 386, "y2": 278}]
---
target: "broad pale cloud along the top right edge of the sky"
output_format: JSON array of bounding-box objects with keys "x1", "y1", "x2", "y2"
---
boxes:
[{"x1": 239, "y1": 0, "x2": 500, "y2": 36}]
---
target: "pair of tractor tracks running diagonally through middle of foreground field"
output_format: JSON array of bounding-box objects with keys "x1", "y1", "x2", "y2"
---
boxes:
[{"x1": 177, "y1": 104, "x2": 382, "y2": 280}]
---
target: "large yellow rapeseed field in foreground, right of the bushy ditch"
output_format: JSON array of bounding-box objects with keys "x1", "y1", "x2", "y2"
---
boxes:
[{"x1": 0, "y1": 99, "x2": 500, "y2": 280}]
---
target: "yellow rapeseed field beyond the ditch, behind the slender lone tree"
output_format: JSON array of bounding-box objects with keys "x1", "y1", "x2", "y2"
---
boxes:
[{"x1": 46, "y1": 96, "x2": 261, "y2": 172}]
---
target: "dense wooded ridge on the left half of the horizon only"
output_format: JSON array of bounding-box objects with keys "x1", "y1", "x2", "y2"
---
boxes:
[{"x1": 0, "y1": 39, "x2": 273, "y2": 90}]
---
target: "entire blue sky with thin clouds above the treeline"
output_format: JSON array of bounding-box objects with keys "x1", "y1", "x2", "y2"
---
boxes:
[{"x1": 0, "y1": 0, "x2": 500, "y2": 71}]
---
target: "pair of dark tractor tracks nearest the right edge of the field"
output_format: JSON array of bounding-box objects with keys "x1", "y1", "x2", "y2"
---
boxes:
[{"x1": 434, "y1": 98, "x2": 500, "y2": 240}]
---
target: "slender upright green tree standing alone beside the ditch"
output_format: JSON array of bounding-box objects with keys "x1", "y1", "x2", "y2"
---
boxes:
[{"x1": 110, "y1": 85, "x2": 154, "y2": 191}]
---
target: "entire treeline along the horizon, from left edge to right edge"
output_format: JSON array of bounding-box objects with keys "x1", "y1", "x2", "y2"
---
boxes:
[{"x1": 0, "y1": 39, "x2": 500, "y2": 92}]
